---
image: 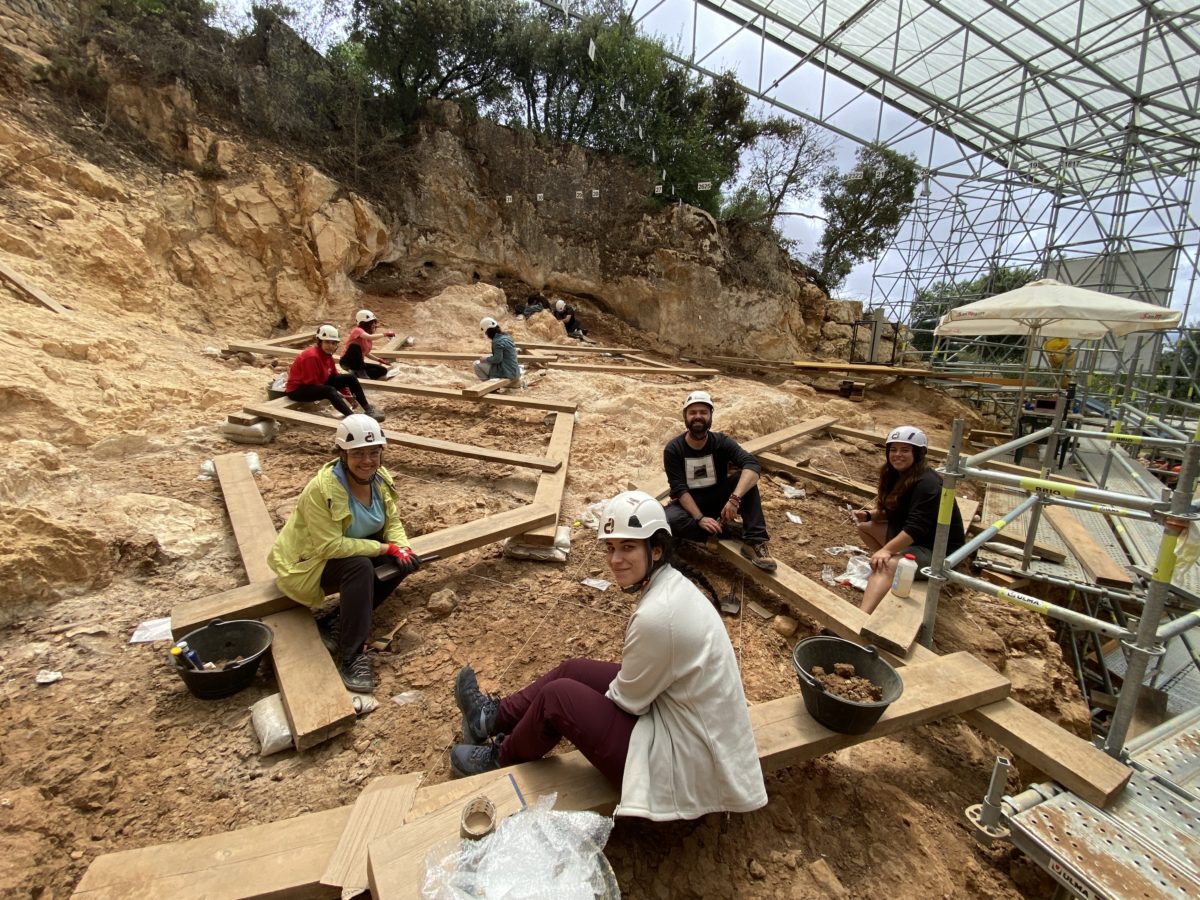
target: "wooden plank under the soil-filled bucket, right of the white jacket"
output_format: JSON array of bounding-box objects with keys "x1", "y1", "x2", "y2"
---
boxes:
[{"x1": 750, "y1": 650, "x2": 1010, "y2": 773}]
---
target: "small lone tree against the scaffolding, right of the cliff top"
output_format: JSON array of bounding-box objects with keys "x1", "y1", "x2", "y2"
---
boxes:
[{"x1": 811, "y1": 144, "x2": 920, "y2": 292}]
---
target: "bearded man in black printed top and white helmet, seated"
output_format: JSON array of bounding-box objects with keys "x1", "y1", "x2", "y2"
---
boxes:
[{"x1": 662, "y1": 391, "x2": 776, "y2": 572}]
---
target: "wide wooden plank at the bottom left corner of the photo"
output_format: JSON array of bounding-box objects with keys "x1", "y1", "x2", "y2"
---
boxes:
[{"x1": 73, "y1": 806, "x2": 352, "y2": 900}]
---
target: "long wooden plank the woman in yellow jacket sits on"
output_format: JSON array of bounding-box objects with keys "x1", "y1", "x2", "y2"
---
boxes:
[{"x1": 170, "y1": 504, "x2": 558, "y2": 638}]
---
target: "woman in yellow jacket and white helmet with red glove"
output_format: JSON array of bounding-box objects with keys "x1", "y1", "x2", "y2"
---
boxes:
[{"x1": 266, "y1": 414, "x2": 420, "y2": 694}]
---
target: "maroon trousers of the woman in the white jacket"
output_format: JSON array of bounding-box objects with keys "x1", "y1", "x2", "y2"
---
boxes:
[{"x1": 496, "y1": 659, "x2": 637, "y2": 788}]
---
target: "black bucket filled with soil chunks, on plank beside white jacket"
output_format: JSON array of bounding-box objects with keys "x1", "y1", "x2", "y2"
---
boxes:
[{"x1": 792, "y1": 636, "x2": 904, "y2": 734}]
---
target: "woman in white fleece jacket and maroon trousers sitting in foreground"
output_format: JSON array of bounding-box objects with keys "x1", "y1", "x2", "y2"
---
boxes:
[{"x1": 450, "y1": 491, "x2": 767, "y2": 821}]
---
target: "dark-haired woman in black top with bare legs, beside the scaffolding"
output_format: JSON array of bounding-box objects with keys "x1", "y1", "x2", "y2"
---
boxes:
[{"x1": 851, "y1": 425, "x2": 966, "y2": 613}]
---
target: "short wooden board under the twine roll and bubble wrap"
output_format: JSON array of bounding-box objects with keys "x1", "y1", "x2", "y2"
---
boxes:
[{"x1": 367, "y1": 772, "x2": 524, "y2": 900}]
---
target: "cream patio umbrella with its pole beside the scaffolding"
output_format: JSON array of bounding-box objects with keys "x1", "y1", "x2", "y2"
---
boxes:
[{"x1": 934, "y1": 278, "x2": 1183, "y2": 416}]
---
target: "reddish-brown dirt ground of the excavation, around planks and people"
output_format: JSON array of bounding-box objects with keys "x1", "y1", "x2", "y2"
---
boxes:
[{"x1": 0, "y1": 277, "x2": 1086, "y2": 900}]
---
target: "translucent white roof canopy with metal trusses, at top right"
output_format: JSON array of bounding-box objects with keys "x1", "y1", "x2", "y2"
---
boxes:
[{"x1": 696, "y1": 0, "x2": 1200, "y2": 191}]
